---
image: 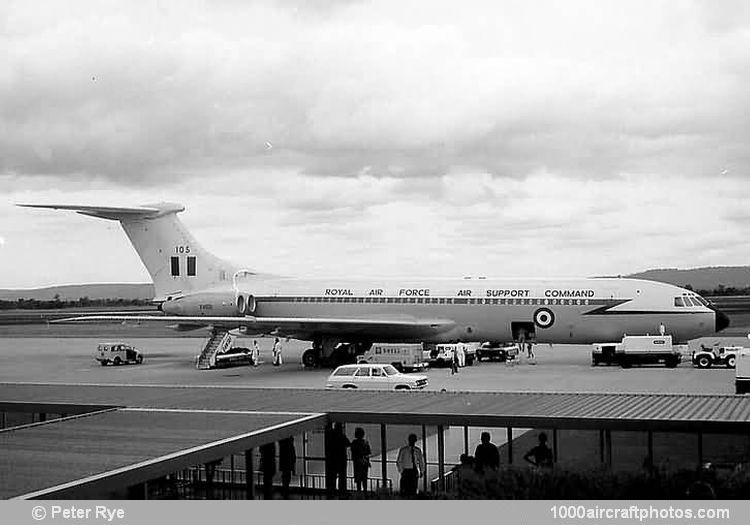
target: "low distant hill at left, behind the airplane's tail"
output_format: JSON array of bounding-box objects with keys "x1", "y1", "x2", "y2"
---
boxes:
[{"x1": 0, "y1": 283, "x2": 154, "y2": 301}]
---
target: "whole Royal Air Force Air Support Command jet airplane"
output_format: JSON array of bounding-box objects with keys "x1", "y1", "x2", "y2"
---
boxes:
[{"x1": 19, "y1": 203, "x2": 729, "y2": 367}]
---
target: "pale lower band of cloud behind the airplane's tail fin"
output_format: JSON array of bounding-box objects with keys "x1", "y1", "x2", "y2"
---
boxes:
[{"x1": 0, "y1": 171, "x2": 750, "y2": 286}]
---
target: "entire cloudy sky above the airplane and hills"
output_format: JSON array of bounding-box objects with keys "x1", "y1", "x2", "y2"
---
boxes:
[{"x1": 0, "y1": 0, "x2": 750, "y2": 288}]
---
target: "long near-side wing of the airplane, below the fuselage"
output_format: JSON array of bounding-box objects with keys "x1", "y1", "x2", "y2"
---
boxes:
[{"x1": 52, "y1": 315, "x2": 455, "y2": 339}]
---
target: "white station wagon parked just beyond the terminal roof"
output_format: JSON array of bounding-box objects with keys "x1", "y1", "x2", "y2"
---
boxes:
[{"x1": 326, "y1": 364, "x2": 427, "y2": 390}]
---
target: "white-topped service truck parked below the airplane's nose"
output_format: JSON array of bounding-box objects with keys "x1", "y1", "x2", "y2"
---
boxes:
[{"x1": 591, "y1": 335, "x2": 682, "y2": 368}]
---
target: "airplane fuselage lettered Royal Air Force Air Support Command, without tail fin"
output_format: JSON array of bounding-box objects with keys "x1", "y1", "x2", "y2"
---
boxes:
[{"x1": 165, "y1": 278, "x2": 716, "y2": 344}]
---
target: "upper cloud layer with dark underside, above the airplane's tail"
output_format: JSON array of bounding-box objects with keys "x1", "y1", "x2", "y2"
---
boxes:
[{"x1": 0, "y1": 1, "x2": 750, "y2": 185}]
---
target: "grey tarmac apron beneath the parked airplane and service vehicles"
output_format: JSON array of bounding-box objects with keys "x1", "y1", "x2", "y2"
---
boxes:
[{"x1": 0, "y1": 336, "x2": 747, "y2": 394}]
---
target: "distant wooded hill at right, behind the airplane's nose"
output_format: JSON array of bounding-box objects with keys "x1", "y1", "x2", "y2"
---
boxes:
[{"x1": 628, "y1": 266, "x2": 750, "y2": 290}]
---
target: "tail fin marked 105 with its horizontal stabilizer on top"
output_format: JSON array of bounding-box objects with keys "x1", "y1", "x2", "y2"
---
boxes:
[{"x1": 19, "y1": 203, "x2": 237, "y2": 301}]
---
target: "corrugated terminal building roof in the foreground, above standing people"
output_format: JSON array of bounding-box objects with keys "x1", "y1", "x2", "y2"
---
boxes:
[{"x1": 0, "y1": 384, "x2": 750, "y2": 498}]
